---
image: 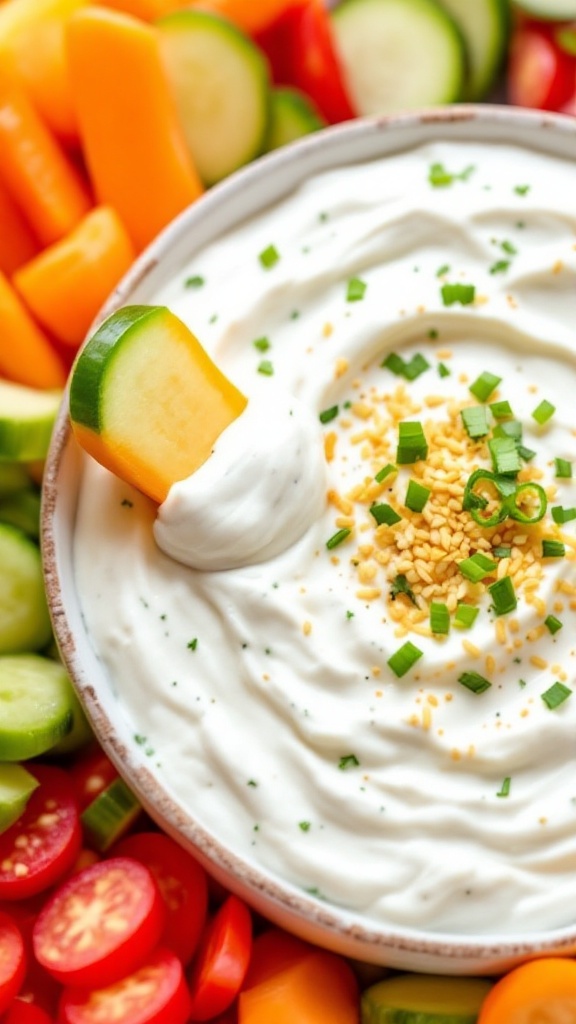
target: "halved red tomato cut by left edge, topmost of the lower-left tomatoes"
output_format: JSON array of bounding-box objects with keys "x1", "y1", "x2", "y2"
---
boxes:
[{"x1": 0, "y1": 765, "x2": 82, "y2": 900}]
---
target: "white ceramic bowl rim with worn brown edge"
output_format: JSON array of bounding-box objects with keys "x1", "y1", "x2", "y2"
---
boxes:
[{"x1": 42, "y1": 106, "x2": 576, "y2": 975}]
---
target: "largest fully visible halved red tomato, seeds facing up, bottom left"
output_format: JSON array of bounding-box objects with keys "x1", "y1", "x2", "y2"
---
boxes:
[{"x1": 32, "y1": 857, "x2": 165, "y2": 988}]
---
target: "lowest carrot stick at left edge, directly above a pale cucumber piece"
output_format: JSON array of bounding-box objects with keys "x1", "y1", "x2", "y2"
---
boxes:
[{"x1": 0, "y1": 272, "x2": 66, "y2": 388}]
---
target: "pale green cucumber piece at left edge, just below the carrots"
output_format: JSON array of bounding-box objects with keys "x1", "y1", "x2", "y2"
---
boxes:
[{"x1": 0, "y1": 381, "x2": 61, "y2": 462}]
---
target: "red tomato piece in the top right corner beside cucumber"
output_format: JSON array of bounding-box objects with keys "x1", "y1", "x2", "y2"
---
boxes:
[{"x1": 507, "y1": 22, "x2": 576, "y2": 111}]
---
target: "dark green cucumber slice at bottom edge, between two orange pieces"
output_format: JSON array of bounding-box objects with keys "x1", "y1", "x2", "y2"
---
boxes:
[{"x1": 362, "y1": 974, "x2": 492, "y2": 1024}]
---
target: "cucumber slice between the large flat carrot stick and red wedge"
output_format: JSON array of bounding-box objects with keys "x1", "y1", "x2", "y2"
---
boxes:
[{"x1": 156, "y1": 10, "x2": 270, "y2": 185}]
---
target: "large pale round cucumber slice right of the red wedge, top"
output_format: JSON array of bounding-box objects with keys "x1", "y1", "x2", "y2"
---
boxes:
[{"x1": 331, "y1": 0, "x2": 463, "y2": 115}]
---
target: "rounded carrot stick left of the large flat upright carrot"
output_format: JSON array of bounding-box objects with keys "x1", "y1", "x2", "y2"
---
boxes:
[{"x1": 0, "y1": 75, "x2": 90, "y2": 245}]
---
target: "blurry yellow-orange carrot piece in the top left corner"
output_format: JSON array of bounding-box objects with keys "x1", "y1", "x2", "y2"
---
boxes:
[{"x1": 0, "y1": 0, "x2": 88, "y2": 142}]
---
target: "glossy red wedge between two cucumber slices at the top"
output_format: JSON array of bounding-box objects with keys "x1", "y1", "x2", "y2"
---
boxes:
[{"x1": 256, "y1": 0, "x2": 356, "y2": 124}]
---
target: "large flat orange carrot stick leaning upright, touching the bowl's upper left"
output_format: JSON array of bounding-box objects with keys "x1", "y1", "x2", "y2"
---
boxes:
[{"x1": 67, "y1": 7, "x2": 202, "y2": 250}]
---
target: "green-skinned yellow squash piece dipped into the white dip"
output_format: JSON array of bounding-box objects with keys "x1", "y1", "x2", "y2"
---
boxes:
[{"x1": 70, "y1": 306, "x2": 247, "y2": 502}]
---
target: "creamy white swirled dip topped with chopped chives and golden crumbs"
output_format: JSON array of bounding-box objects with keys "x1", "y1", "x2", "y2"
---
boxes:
[{"x1": 74, "y1": 141, "x2": 576, "y2": 935}]
